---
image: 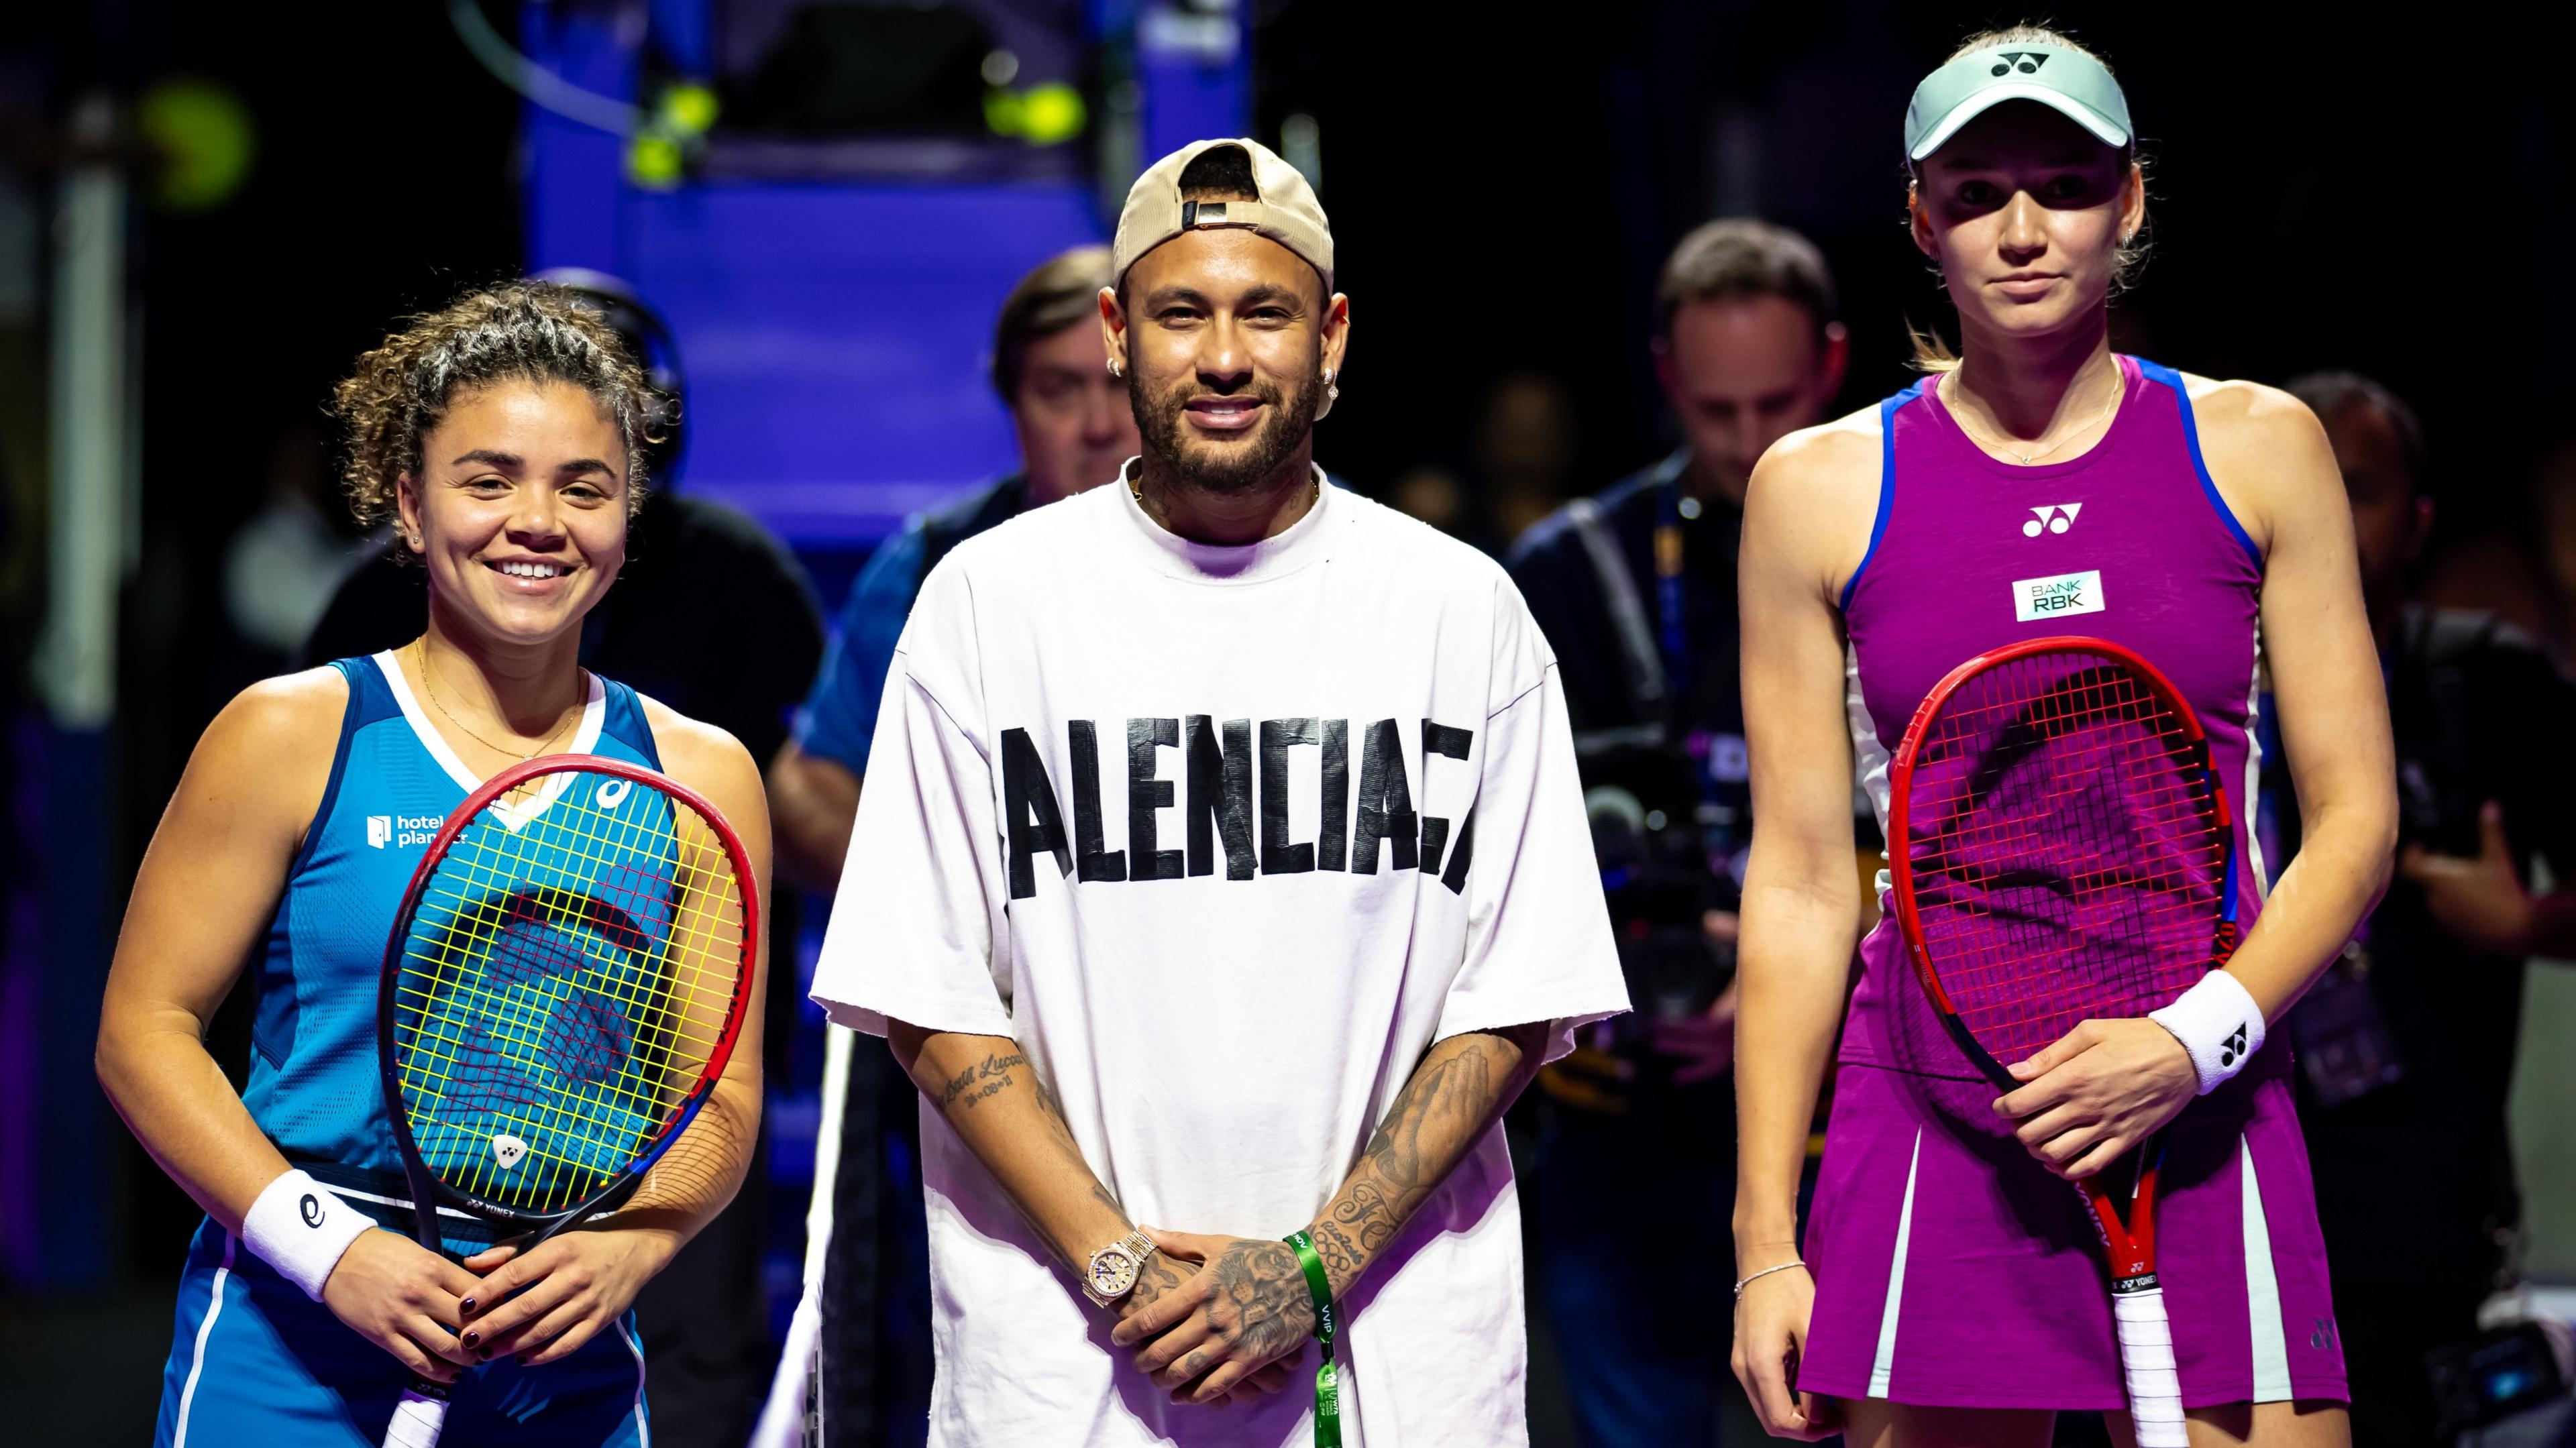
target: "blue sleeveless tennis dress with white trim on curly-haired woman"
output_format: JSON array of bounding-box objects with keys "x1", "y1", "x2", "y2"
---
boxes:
[{"x1": 154, "y1": 652, "x2": 662, "y2": 1448}]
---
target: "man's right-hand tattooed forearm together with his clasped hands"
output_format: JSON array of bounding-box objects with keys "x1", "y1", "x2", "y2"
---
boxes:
[{"x1": 1110, "y1": 1023, "x2": 1548, "y2": 1402}]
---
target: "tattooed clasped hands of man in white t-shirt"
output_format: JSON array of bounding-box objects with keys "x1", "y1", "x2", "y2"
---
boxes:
[{"x1": 1110, "y1": 1227, "x2": 1313, "y2": 1407}]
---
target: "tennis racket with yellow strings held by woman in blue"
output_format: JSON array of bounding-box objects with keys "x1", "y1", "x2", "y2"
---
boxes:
[{"x1": 376, "y1": 755, "x2": 760, "y2": 1448}]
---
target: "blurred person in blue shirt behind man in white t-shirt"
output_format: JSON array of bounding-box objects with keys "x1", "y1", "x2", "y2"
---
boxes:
[{"x1": 770, "y1": 247, "x2": 1141, "y2": 1445}]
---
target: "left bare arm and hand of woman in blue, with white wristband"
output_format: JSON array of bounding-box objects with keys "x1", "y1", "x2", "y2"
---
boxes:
[{"x1": 98, "y1": 670, "x2": 474, "y2": 1381}]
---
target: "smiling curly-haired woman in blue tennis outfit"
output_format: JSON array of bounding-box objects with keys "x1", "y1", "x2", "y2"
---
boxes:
[{"x1": 98, "y1": 284, "x2": 767, "y2": 1448}]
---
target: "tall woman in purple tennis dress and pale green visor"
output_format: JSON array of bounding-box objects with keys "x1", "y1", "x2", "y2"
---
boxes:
[{"x1": 1736, "y1": 28, "x2": 2396, "y2": 1448}]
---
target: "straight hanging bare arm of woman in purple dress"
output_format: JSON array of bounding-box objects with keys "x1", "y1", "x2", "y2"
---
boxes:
[{"x1": 1733, "y1": 417, "x2": 1878, "y2": 1438}]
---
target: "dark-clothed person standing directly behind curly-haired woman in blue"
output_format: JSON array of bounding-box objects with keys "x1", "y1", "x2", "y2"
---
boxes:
[{"x1": 304, "y1": 268, "x2": 822, "y2": 1448}]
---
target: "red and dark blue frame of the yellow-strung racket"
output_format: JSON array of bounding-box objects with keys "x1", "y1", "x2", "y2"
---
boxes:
[{"x1": 376, "y1": 755, "x2": 760, "y2": 1236}]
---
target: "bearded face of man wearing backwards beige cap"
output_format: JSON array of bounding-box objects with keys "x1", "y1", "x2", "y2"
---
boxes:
[{"x1": 1100, "y1": 227, "x2": 1350, "y2": 492}]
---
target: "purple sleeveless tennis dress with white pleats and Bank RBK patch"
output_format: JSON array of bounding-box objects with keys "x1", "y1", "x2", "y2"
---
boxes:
[{"x1": 1798, "y1": 355, "x2": 2347, "y2": 1409}]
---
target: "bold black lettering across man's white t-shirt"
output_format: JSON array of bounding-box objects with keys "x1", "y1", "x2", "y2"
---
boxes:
[{"x1": 1002, "y1": 714, "x2": 1476, "y2": 899}]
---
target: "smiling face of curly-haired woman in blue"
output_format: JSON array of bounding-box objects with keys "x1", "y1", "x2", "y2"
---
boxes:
[{"x1": 399, "y1": 382, "x2": 626, "y2": 647}]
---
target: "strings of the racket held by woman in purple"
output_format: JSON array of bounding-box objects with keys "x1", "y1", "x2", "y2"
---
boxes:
[{"x1": 1907, "y1": 652, "x2": 2229, "y2": 1064}]
